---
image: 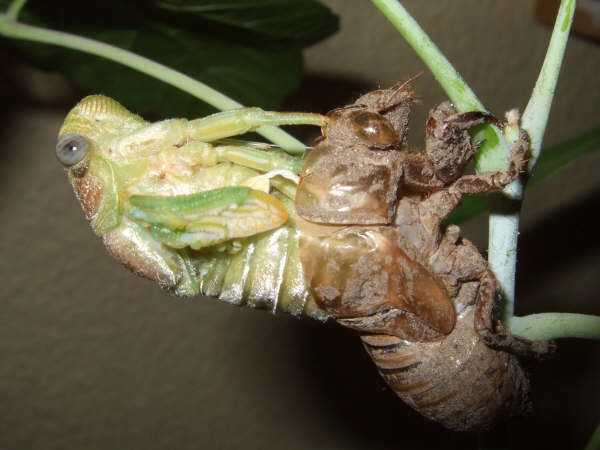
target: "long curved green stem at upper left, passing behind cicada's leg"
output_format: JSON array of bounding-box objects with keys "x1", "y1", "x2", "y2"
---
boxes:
[{"x1": 0, "y1": 14, "x2": 306, "y2": 154}]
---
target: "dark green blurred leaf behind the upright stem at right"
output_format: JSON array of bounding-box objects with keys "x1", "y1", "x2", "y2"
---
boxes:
[{"x1": 445, "y1": 126, "x2": 600, "y2": 224}]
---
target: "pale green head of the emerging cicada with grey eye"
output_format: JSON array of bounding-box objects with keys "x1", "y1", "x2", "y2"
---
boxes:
[{"x1": 56, "y1": 95, "x2": 145, "y2": 236}]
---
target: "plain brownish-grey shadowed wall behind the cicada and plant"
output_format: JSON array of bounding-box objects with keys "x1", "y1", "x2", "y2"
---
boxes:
[{"x1": 0, "y1": 0, "x2": 600, "y2": 450}]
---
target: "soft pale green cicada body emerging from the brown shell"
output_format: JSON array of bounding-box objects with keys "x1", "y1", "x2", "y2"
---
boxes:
[{"x1": 56, "y1": 96, "x2": 326, "y2": 319}]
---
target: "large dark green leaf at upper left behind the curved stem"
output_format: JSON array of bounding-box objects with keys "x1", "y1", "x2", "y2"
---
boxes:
[{"x1": 0, "y1": 0, "x2": 336, "y2": 117}]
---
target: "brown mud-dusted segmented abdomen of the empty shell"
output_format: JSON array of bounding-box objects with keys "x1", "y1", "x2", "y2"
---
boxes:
[{"x1": 361, "y1": 306, "x2": 529, "y2": 430}]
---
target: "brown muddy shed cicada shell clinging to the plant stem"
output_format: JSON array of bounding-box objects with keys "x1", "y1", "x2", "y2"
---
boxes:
[{"x1": 296, "y1": 84, "x2": 540, "y2": 430}]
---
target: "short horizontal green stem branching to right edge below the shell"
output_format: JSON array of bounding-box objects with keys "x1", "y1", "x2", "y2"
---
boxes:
[{"x1": 509, "y1": 313, "x2": 600, "y2": 340}]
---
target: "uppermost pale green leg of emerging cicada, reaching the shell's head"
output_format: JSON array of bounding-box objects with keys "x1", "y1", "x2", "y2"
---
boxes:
[{"x1": 189, "y1": 108, "x2": 326, "y2": 142}]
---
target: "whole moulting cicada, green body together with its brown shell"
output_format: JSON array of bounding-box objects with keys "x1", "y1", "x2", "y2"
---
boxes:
[{"x1": 56, "y1": 83, "x2": 540, "y2": 430}]
